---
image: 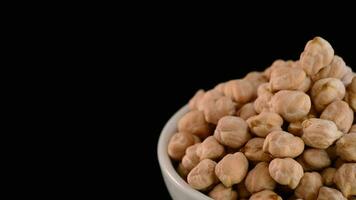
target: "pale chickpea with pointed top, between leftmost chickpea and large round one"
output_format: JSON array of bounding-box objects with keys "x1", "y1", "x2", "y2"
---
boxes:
[{"x1": 196, "y1": 136, "x2": 225, "y2": 160}]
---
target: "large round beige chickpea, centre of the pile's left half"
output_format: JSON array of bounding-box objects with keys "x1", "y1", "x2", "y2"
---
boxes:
[{"x1": 214, "y1": 116, "x2": 251, "y2": 148}]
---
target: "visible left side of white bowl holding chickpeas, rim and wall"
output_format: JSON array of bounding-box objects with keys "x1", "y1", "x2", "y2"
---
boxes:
[{"x1": 157, "y1": 106, "x2": 211, "y2": 200}]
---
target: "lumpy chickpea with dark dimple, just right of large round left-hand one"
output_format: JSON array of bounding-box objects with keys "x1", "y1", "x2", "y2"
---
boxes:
[{"x1": 246, "y1": 111, "x2": 283, "y2": 137}]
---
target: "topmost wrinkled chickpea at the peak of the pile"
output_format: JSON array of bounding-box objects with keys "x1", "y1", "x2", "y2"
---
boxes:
[{"x1": 300, "y1": 37, "x2": 334, "y2": 76}]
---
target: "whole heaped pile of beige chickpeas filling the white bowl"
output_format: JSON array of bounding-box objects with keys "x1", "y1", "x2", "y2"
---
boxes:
[{"x1": 168, "y1": 37, "x2": 356, "y2": 200}]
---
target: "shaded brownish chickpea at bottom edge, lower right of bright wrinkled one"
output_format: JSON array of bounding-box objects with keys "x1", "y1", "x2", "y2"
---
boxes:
[{"x1": 294, "y1": 172, "x2": 323, "y2": 200}]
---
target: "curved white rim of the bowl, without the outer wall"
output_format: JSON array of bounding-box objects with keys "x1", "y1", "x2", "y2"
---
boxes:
[{"x1": 157, "y1": 105, "x2": 211, "y2": 200}]
